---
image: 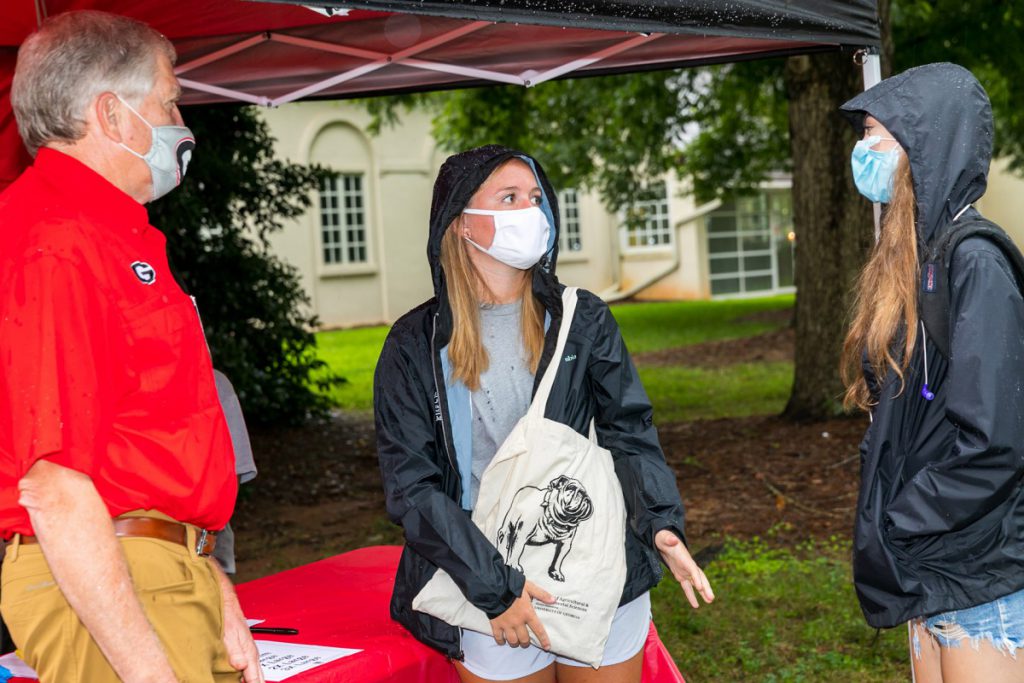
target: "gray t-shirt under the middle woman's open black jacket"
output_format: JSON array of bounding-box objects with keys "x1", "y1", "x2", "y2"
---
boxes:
[{"x1": 469, "y1": 301, "x2": 534, "y2": 507}]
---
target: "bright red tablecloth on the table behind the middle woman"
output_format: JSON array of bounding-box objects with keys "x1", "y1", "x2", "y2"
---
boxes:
[{"x1": 238, "y1": 546, "x2": 685, "y2": 683}]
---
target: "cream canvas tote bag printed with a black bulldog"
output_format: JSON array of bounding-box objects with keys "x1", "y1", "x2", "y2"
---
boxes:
[{"x1": 413, "y1": 288, "x2": 626, "y2": 668}]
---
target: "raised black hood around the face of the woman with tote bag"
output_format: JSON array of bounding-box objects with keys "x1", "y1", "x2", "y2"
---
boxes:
[{"x1": 427, "y1": 144, "x2": 558, "y2": 298}]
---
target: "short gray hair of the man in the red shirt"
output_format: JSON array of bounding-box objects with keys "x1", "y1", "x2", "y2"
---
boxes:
[{"x1": 10, "y1": 10, "x2": 175, "y2": 157}]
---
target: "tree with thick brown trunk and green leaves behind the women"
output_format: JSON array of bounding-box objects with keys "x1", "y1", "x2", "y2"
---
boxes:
[{"x1": 362, "y1": 0, "x2": 1024, "y2": 418}]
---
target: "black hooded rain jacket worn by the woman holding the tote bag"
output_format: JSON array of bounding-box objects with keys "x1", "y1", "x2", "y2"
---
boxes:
[{"x1": 374, "y1": 145, "x2": 683, "y2": 659}]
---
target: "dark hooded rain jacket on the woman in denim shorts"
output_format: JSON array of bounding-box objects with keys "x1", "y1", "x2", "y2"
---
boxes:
[{"x1": 842, "y1": 63, "x2": 1024, "y2": 627}]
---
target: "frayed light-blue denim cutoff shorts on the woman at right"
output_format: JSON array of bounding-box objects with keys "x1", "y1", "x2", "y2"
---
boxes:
[{"x1": 924, "y1": 590, "x2": 1024, "y2": 656}]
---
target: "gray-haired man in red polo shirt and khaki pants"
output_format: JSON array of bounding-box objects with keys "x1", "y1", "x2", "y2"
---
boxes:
[{"x1": 0, "y1": 12, "x2": 263, "y2": 683}]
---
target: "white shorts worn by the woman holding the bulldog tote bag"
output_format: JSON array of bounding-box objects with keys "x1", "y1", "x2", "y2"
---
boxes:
[{"x1": 462, "y1": 593, "x2": 650, "y2": 681}]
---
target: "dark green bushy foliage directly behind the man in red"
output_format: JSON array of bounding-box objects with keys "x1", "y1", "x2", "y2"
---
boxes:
[{"x1": 150, "y1": 105, "x2": 339, "y2": 424}]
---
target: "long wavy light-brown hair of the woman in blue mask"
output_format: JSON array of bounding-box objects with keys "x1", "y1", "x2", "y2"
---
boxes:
[{"x1": 840, "y1": 153, "x2": 921, "y2": 411}]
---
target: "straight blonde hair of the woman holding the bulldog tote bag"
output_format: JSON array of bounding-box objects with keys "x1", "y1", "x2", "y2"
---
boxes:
[{"x1": 441, "y1": 222, "x2": 544, "y2": 391}]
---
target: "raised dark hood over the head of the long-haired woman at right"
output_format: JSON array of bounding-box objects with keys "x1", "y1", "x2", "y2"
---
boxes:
[{"x1": 841, "y1": 62, "x2": 992, "y2": 244}]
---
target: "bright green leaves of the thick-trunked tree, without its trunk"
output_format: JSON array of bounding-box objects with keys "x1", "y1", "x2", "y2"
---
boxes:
[{"x1": 367, "y1": 0, "x2": 1024, "y2": 214}]
